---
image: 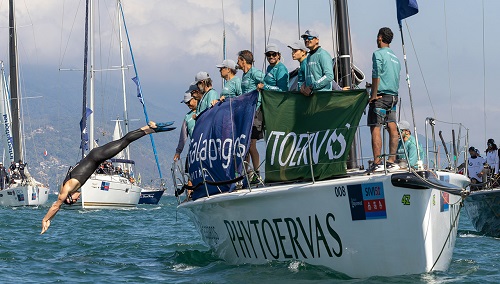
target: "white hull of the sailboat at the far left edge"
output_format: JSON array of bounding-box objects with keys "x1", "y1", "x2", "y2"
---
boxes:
[{"x1": 0, "y1": 180, "x2": 49, "y2": 207}]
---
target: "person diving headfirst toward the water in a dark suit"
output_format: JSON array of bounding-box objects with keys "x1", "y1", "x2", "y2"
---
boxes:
[{"x1": 40, "y1": 121, "x2": 175, "y2": 234}]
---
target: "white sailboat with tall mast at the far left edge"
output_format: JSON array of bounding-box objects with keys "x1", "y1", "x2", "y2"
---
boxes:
[{"x1": 0, "y1": 0, "x2": 49, "y2": 209}]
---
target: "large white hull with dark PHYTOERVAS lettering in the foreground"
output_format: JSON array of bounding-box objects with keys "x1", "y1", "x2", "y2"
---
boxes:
[{"x1": 179, "y1": 173, "x2": 466, "y2": 278}]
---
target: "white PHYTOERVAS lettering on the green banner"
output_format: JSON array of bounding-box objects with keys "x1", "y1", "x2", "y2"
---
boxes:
[{"x1": 267, "y1": 125, "x2": 349, "y2": 167}]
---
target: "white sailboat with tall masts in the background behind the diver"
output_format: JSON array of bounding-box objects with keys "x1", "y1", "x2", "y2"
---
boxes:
[{"x1": 69, "y1": 0, "x2": 142, "y2": 209}]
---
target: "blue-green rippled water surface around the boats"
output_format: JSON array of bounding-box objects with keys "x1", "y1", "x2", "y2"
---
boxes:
[{"x1": 0, "y1": 195, "x2": 500, "y2": 284}]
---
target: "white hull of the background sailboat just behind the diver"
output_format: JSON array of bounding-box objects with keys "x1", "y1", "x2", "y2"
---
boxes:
[{"x1": 77, "y1": 174, "x2": 141, "y2": 209}]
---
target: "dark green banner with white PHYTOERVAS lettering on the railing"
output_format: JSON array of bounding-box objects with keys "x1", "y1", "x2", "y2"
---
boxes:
[{"x1": 262, "y1": 89, "x2": 368, "y2": 182}]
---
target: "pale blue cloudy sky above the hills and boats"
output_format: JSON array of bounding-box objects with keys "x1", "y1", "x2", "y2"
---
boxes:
[{"x1": 0, "y1": 0, "x2": 500, "y2": 166}]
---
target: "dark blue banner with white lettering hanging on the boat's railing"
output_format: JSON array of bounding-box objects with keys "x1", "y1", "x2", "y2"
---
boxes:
[{"x1": 188, "y1": 91, "x2": 258, "y2": 200}]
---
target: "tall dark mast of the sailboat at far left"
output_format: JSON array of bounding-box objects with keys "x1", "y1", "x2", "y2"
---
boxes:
[{"x1": 9, "y1": 0, "x2": 24, "y2": 160}]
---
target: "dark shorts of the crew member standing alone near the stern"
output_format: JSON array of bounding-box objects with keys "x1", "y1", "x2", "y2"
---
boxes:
[{"x1": 367, "y1": 94, "x2": 398, "y2": 126}]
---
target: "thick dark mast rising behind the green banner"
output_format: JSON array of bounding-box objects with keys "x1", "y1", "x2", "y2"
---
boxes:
[{"x1": 335, "y1": 0, "x2": 358, "y2": 169}]
